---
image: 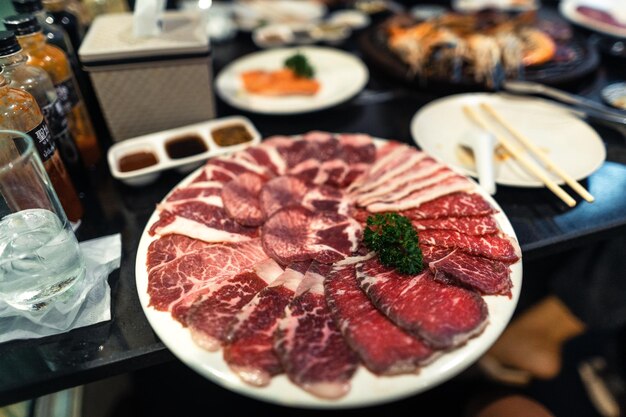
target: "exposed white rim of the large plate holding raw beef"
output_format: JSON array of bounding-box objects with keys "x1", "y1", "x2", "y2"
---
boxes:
[{"x1": 135, "y1": 137, "x2": 522, "y2": 408}]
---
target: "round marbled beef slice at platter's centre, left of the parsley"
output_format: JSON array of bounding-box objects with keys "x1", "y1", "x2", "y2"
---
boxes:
[{"x1": 261, "y1": 207, "x2": 362, "y2": 265}]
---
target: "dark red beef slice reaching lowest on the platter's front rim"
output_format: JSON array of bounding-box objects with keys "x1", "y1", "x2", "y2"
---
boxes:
[{"x1": 274, "y1": 262, "x2": 359, "y2": 399}]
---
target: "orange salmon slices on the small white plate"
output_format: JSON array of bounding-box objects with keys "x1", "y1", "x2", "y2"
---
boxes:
[{"x1": 241, "y1": 68, "x2": 320, "y2": 96}]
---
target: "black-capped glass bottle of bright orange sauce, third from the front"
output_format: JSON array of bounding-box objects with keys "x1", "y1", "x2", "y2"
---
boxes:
[{"x1": 4, "y1": 14, "x2": 100, "y2": 166}]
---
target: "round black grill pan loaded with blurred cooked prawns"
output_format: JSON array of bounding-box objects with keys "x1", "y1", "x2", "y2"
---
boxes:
[{"x1": 359, "y1": 10, "x2": 599, "y2": 89}]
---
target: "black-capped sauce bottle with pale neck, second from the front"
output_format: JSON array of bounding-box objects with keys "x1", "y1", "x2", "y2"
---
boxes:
[{"x1": 0, "y1": 31, "x2": 86, "y2": 191}]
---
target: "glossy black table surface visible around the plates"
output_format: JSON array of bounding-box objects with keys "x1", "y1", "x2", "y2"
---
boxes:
[{"x1": 0, "y1": 8, "x2": 626, "y2": 405}]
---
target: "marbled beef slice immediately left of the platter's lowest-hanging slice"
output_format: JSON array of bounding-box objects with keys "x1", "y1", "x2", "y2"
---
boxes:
[{"x1": 224, "y1": 263, "x2": 308, "y2": 386}]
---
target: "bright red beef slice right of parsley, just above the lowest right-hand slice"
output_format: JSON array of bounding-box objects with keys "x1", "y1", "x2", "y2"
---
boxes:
[{"x1": 419, "y1": 230, "x2": 521, "y2": 263}]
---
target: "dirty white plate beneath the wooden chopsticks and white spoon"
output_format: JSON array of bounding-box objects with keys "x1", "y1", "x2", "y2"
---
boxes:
[{"x1": 411, "y1": 93, "x2": 606, "y2": 187}]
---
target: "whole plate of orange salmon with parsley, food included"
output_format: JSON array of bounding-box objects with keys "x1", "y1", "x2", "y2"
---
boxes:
[{"x1": 215, "y1": 46, "x2": 369, "y2": 114}]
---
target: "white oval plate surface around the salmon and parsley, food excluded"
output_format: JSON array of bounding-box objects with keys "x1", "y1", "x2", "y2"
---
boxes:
[{"x1": 215, "y1": 46, "x2": 369, "y2": 114}]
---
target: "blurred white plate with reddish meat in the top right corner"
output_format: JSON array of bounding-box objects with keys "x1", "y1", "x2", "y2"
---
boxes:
[{"x1": 559, "y1": 0, "x2": 626, "y2": 38}]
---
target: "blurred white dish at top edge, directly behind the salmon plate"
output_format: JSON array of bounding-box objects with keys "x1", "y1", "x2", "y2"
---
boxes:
[{"x1": 233, "y1": 0, "x2": 327, "y2": 31}]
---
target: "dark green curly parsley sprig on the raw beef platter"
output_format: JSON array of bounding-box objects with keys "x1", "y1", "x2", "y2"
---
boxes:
[{"x1": 363, "y1": 213, "x2": 424, "y2": 275}]
